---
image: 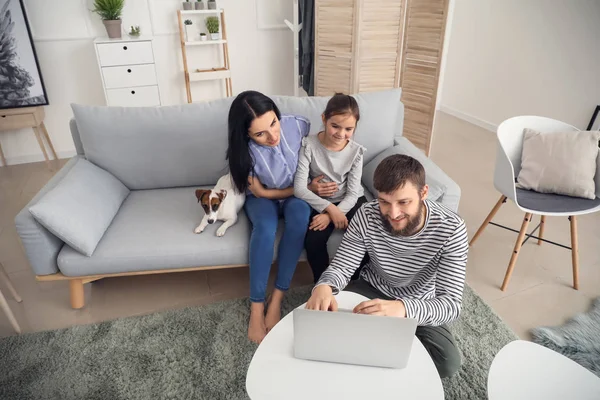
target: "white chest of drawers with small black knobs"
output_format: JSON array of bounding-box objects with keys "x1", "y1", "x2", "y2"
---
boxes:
[{"x1": 94, "y1": 36, "x2": 161, "y2": 107}]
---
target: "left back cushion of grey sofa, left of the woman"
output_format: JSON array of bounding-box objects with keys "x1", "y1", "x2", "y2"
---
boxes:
[{"x1": 72, "y1": 99, "x2": 232, "y2": 190}]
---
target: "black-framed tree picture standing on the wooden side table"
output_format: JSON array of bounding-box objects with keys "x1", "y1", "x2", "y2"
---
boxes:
[{"x1": 0, "y1": 0, "x2": 48, "y2": 109}]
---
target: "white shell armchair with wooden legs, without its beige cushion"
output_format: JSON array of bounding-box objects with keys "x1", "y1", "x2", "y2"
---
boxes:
[{"x1": 469, "y1": 116, "x2": 600, "y2": 291}]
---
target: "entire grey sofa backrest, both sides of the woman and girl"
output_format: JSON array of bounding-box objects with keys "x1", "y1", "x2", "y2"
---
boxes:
[{"x1": 71, "y1": 89, "x2": 404, "y2": 190}]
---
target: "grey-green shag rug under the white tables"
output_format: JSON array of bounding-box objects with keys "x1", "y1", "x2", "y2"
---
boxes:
[{"x1": 0, "y1": 287, "x2": 517, "y2": 400}]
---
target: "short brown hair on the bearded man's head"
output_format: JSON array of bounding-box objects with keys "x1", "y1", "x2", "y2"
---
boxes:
[{"x1": 373, "y1": 154, "x2": 425, "y2": 193}]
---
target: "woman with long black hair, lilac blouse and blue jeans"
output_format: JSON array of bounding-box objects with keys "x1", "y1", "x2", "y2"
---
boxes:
[{"x1": 227, "y1": 91, "x2": 310, "y2": 343}]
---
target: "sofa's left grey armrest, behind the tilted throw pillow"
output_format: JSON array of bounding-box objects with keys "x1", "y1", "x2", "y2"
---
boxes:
[{"x1": 15, "y1": 156, "x2": 83, "y2": 275}]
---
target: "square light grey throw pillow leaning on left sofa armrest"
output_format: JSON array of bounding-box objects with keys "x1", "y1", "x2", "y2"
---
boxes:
[{"x1": 29, "y1": 159, "x2": 129, "y2": 256}]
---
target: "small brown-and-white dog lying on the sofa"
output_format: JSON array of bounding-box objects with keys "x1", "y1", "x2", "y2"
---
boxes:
[{"x1": 194, "y1": 174, "x2": 246, "y2": 236}]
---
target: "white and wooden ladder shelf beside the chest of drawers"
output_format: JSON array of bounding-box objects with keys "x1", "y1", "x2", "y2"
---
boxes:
[{"x1": 177, "y1": 9, "x2": 233, "y2": 103}]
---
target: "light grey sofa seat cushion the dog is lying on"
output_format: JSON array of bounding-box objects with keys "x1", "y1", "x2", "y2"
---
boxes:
[{"x1": 58, "y1": 187, "x2": 350, "y2": 276}]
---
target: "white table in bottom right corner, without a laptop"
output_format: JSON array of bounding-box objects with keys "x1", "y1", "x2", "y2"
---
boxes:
[{"x1": 488, "y1": 340, "x2": 600, "y2": 400}]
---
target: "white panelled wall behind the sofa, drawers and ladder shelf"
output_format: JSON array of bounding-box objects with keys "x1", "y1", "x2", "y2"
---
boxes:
[{"x1": 0, "y1": 0, "x2": 293, "y2": 164}]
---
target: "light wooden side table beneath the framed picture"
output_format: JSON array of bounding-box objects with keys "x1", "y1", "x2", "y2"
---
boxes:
[{"x1": 0, "y1": 107, "x2": 58, "y2": 169}]
